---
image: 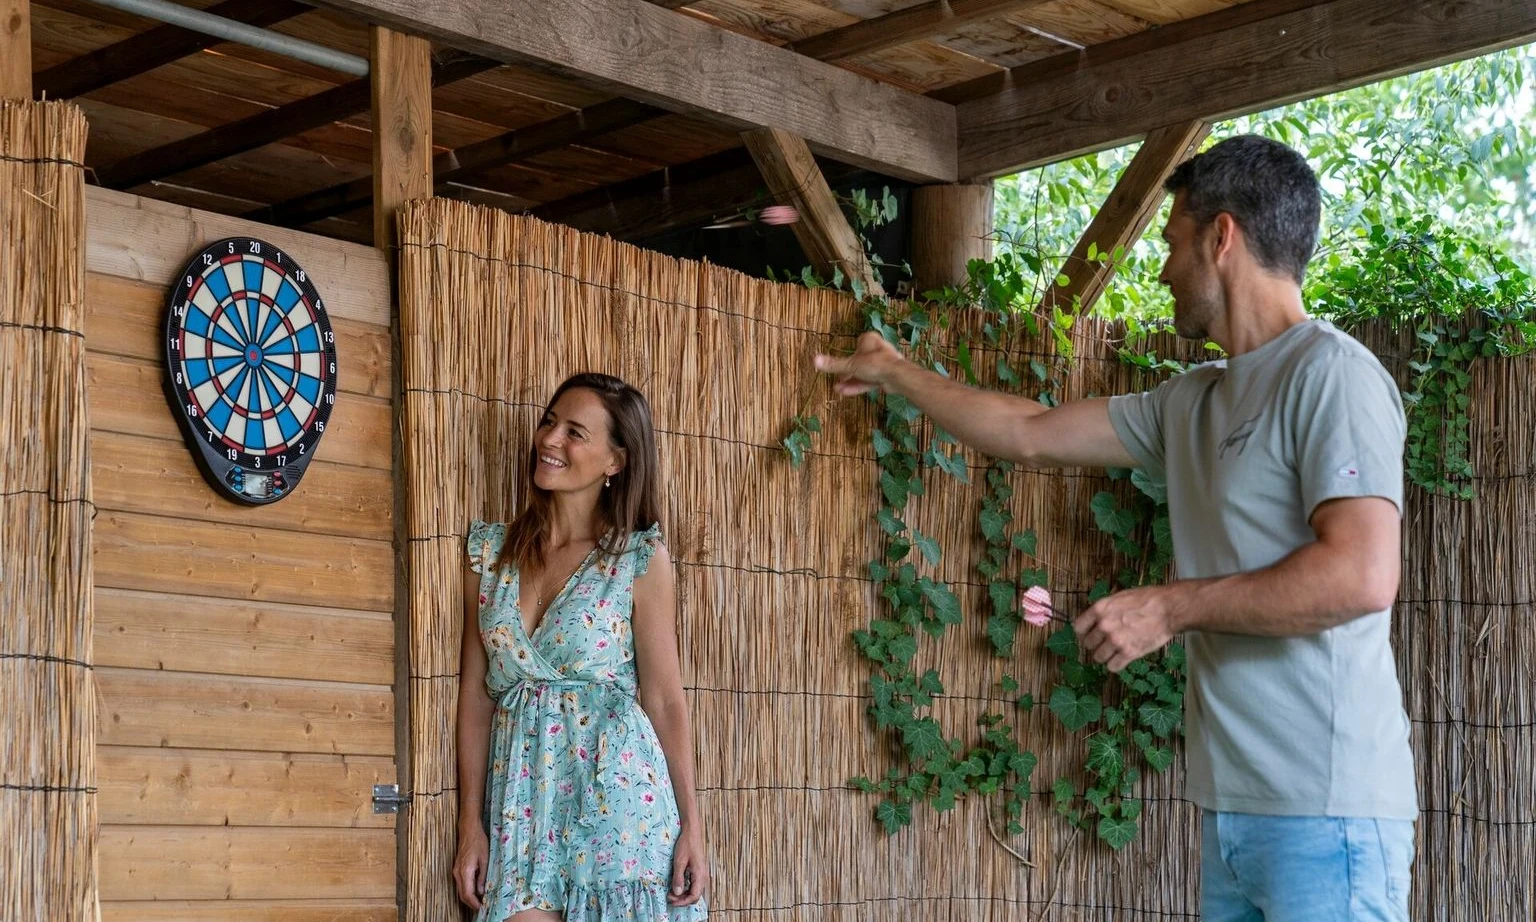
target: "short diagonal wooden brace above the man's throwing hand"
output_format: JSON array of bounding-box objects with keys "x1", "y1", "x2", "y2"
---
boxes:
[{"x1": 742, "y1": 128, "x2": 885, "y2": 295}]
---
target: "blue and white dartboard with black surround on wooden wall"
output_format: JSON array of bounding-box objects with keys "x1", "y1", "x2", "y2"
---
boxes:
[{"x1": 164, "y1": 237, "x2": 336, "y2": 504}]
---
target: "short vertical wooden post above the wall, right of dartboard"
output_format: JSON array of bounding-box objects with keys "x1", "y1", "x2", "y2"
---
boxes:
[{"x1": 369, "y1": 26, "x2": 432, "y2": 250}]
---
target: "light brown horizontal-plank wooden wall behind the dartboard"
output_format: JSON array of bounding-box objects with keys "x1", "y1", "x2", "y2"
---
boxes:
[{"x1": 86, "y1": 187, "x2": 396, "y2": 922}]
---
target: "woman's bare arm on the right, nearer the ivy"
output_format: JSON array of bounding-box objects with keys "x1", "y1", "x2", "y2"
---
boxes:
[{"x1": 633, "y1": 546, "x2": 710, "y2": 905}]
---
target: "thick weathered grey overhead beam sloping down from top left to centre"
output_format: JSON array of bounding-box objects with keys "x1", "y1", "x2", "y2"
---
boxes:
[{"x1": 299, "y1": 0, "x2": 955, "y2": 181}]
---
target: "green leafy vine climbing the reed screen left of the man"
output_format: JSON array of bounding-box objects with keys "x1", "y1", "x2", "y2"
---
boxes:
[{"x1": 783, "y1": 195, "x2": 1184, "y2": 854}]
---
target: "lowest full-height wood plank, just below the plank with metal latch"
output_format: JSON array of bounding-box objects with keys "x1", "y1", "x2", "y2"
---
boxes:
[{"x1": 100, "y1": 825, "x2": 395, "y2": 900}]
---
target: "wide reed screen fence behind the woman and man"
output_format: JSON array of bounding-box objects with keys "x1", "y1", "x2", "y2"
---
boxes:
[{"x1": 401, "y1": 200, "x2": 1536, "y2": 922}]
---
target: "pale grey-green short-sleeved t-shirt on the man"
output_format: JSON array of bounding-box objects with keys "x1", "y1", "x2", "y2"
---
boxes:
[{"x1": 1109, "y1": 320, "x2": 1418, "y2": 819}]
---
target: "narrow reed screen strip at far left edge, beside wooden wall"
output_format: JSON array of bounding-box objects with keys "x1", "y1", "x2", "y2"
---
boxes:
[{"x1": 0, "y1": 100, "x2": 97, "y2": 922}]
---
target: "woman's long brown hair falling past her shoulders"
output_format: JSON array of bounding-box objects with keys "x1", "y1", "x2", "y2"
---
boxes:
[{"x1": 496, "y1": 372, "x2": 660, "y2": 570}]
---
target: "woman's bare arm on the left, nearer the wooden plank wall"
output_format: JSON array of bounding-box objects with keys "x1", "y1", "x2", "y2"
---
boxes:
[{"x1": 453, "y1": 570, "x2": 496, "y2": 910}]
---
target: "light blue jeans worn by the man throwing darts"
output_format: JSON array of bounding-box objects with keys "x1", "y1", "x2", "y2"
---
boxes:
[{"x1": 1200, "y1": 810, "x2": 1413, "y2": 922}]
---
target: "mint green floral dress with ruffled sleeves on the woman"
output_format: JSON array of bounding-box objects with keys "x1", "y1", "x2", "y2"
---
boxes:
[{"x1": 468, "y1": 521, "x2": 707, "y2": 922}]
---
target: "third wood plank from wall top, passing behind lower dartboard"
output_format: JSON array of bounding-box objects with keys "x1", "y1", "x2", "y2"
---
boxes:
[{"x1": 86, "y1": 352, "x2": 393, "y2": 473}]
